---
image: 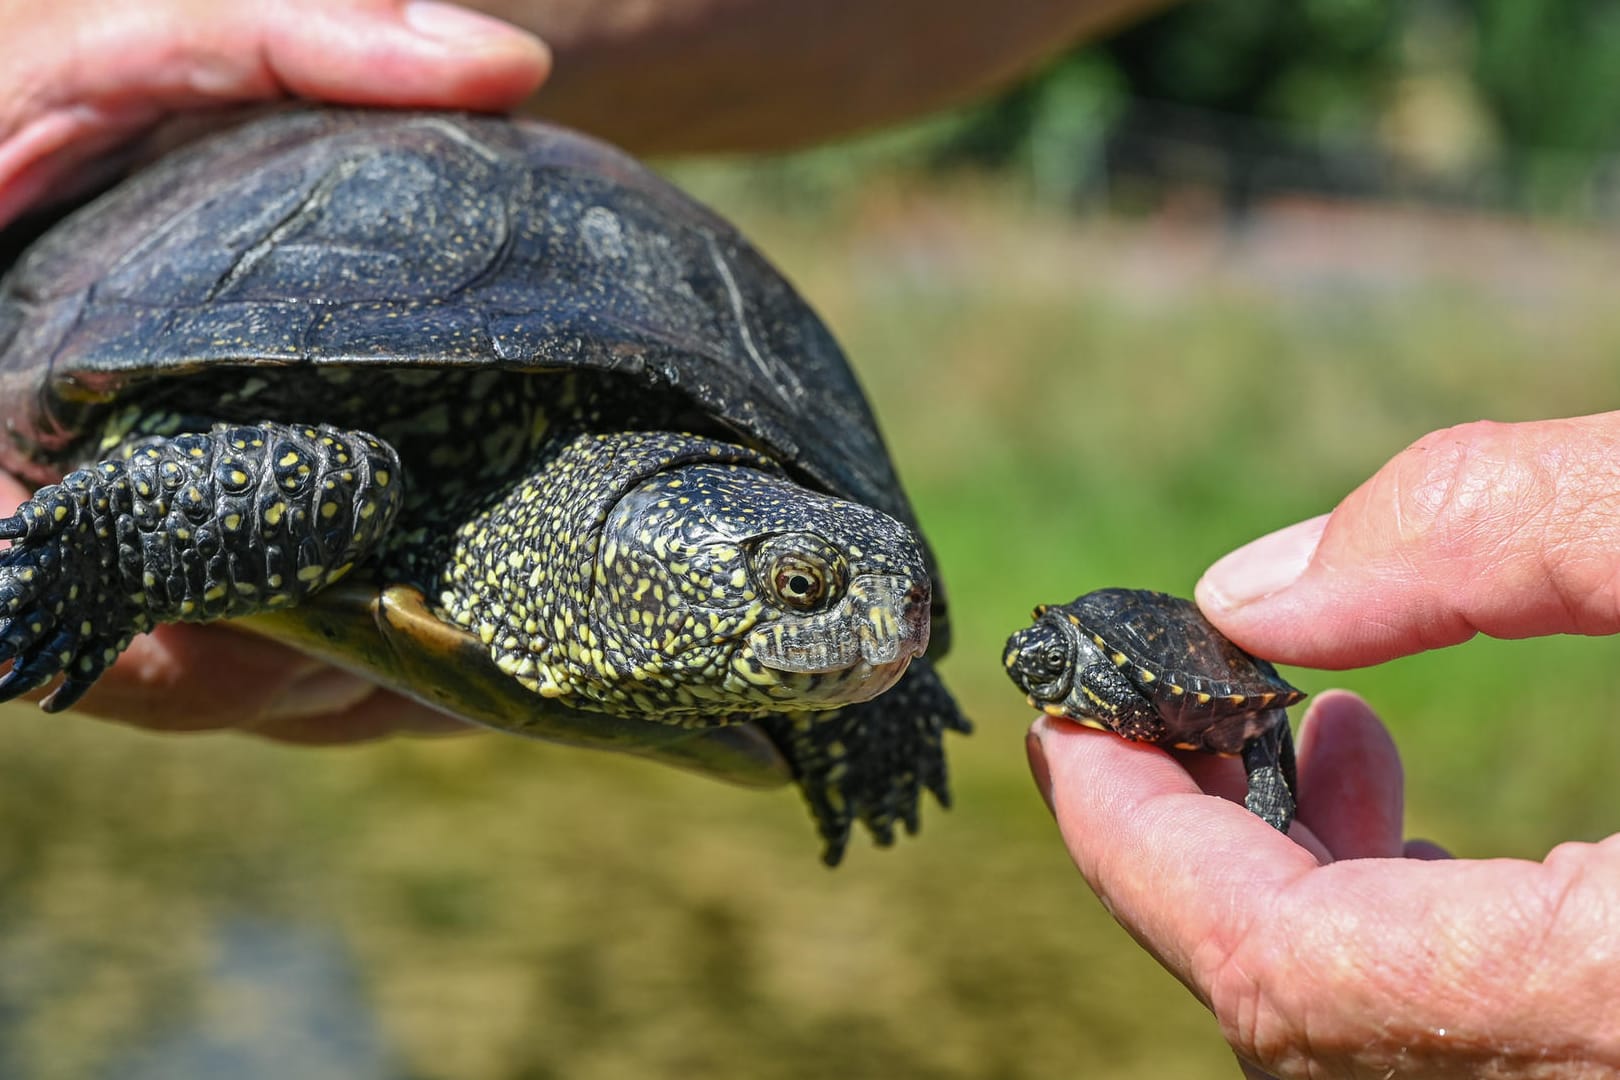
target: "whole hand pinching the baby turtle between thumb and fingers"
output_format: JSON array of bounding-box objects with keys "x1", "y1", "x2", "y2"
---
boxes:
[{"x1": 1032, "y1": 413, "x2": 1620, "y2": 1077}]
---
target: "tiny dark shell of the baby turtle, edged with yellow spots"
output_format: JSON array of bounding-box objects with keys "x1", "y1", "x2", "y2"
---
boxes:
[{"x1": 1063, "y1": 589, "x2": 1306, "y2": 719}]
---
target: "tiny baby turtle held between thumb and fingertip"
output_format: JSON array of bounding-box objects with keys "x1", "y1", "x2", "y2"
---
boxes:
[{"x1": 1003, "y1": 589, "x2": 1306, "y2": 832}]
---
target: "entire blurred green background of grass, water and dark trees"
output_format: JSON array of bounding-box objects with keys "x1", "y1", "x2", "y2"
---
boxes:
[{"x1": 9, "y1": 0, "x2": 1620, "y2": 1080}]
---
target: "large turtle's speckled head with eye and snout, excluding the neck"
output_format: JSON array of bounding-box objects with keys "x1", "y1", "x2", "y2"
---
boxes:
[{"x1": 591, "y1": 463, "x2": 932, "y2": 714}]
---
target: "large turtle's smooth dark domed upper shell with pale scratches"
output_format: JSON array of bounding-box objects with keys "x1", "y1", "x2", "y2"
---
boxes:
[{"x1": 0, "y1": 110, "x2": 948, "y2": 654}]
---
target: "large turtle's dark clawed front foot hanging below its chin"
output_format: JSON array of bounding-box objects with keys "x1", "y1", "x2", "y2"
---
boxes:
[{"x1": 758, "y1": 657, "x2": 970, "y2": 866}]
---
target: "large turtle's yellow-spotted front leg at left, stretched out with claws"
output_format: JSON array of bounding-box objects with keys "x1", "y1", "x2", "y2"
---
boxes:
[{"x1": 0, "y1": 424, "x2": 403, "y2": 711}]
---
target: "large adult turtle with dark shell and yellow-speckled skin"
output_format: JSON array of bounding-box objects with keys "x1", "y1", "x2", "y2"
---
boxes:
[{"x1": 0, "y1": 110, "x2": 967, "y2": 863}]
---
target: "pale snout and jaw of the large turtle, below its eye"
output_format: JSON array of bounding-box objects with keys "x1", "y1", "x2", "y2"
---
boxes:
[{"x1": 747, "y1": 573, "x2": 930, "y2": 708}]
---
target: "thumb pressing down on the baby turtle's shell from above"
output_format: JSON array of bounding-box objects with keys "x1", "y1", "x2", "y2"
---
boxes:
[{"x1": 1197, "y1": 413, "x2": 1620, "y2": 667}]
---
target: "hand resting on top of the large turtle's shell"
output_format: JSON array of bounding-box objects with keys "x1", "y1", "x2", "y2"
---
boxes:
[{"x1": 0, "y1": 0, "x2": 551, "y2": 225}]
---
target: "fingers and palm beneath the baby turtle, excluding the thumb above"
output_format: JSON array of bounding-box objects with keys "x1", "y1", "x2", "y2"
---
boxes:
[{"x1": 1030, "y1": 691, "x2": 1620, "y2": 1078}]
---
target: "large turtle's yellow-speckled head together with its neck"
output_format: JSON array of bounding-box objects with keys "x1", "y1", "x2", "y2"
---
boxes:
[{"x1": 439, "y1": 432, "x2": 932, "y2": 724}]
